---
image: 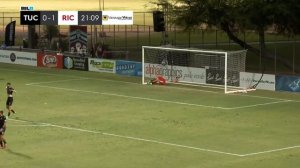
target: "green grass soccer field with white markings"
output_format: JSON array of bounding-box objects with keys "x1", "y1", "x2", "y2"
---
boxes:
[{"x1": 0, "y1": 63, "x2": 300, "y2": 168}]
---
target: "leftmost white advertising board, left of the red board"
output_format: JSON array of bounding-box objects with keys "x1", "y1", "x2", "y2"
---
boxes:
[{"x1": 0, "y1": 50, "x2": 37, "y2": 66}]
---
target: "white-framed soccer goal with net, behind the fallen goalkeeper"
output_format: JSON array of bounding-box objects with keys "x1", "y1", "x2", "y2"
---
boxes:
[{"x1": 142, "y1": 46, "x2": 254, "y2": 93}]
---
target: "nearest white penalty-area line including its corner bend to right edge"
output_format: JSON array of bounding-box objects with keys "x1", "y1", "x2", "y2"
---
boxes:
[{"x1": 9, "y1": 119, "x2": 300, "y2": 157}]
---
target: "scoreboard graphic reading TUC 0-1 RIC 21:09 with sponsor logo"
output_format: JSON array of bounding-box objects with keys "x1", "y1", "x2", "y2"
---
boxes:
[{"x1": 20, "y1": 11, "x2": 133, "y2": 25}]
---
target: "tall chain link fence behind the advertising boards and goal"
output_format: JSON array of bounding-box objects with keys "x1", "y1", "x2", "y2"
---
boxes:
[{"x1": 0, "y1": 12, "x2": 300, "y2": 74}]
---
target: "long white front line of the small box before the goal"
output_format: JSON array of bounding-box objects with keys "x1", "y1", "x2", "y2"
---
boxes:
[{"x1": 28, "y1": 85, "x2": 230, "y2": 110}]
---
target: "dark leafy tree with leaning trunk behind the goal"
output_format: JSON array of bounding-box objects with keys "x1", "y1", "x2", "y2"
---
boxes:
[{"x1": 161, "y1": 0, "x2": 300, "y2": 71}]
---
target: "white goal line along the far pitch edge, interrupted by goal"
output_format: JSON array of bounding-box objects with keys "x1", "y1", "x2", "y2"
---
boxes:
[{"x1": 0, "y1": 68, "x2": 300, "y2": 102}]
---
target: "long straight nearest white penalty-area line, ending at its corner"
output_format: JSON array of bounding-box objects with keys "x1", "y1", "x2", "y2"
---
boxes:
[{"x1": 9, "y1": 119, "x2": 242, "y2": 157}]
